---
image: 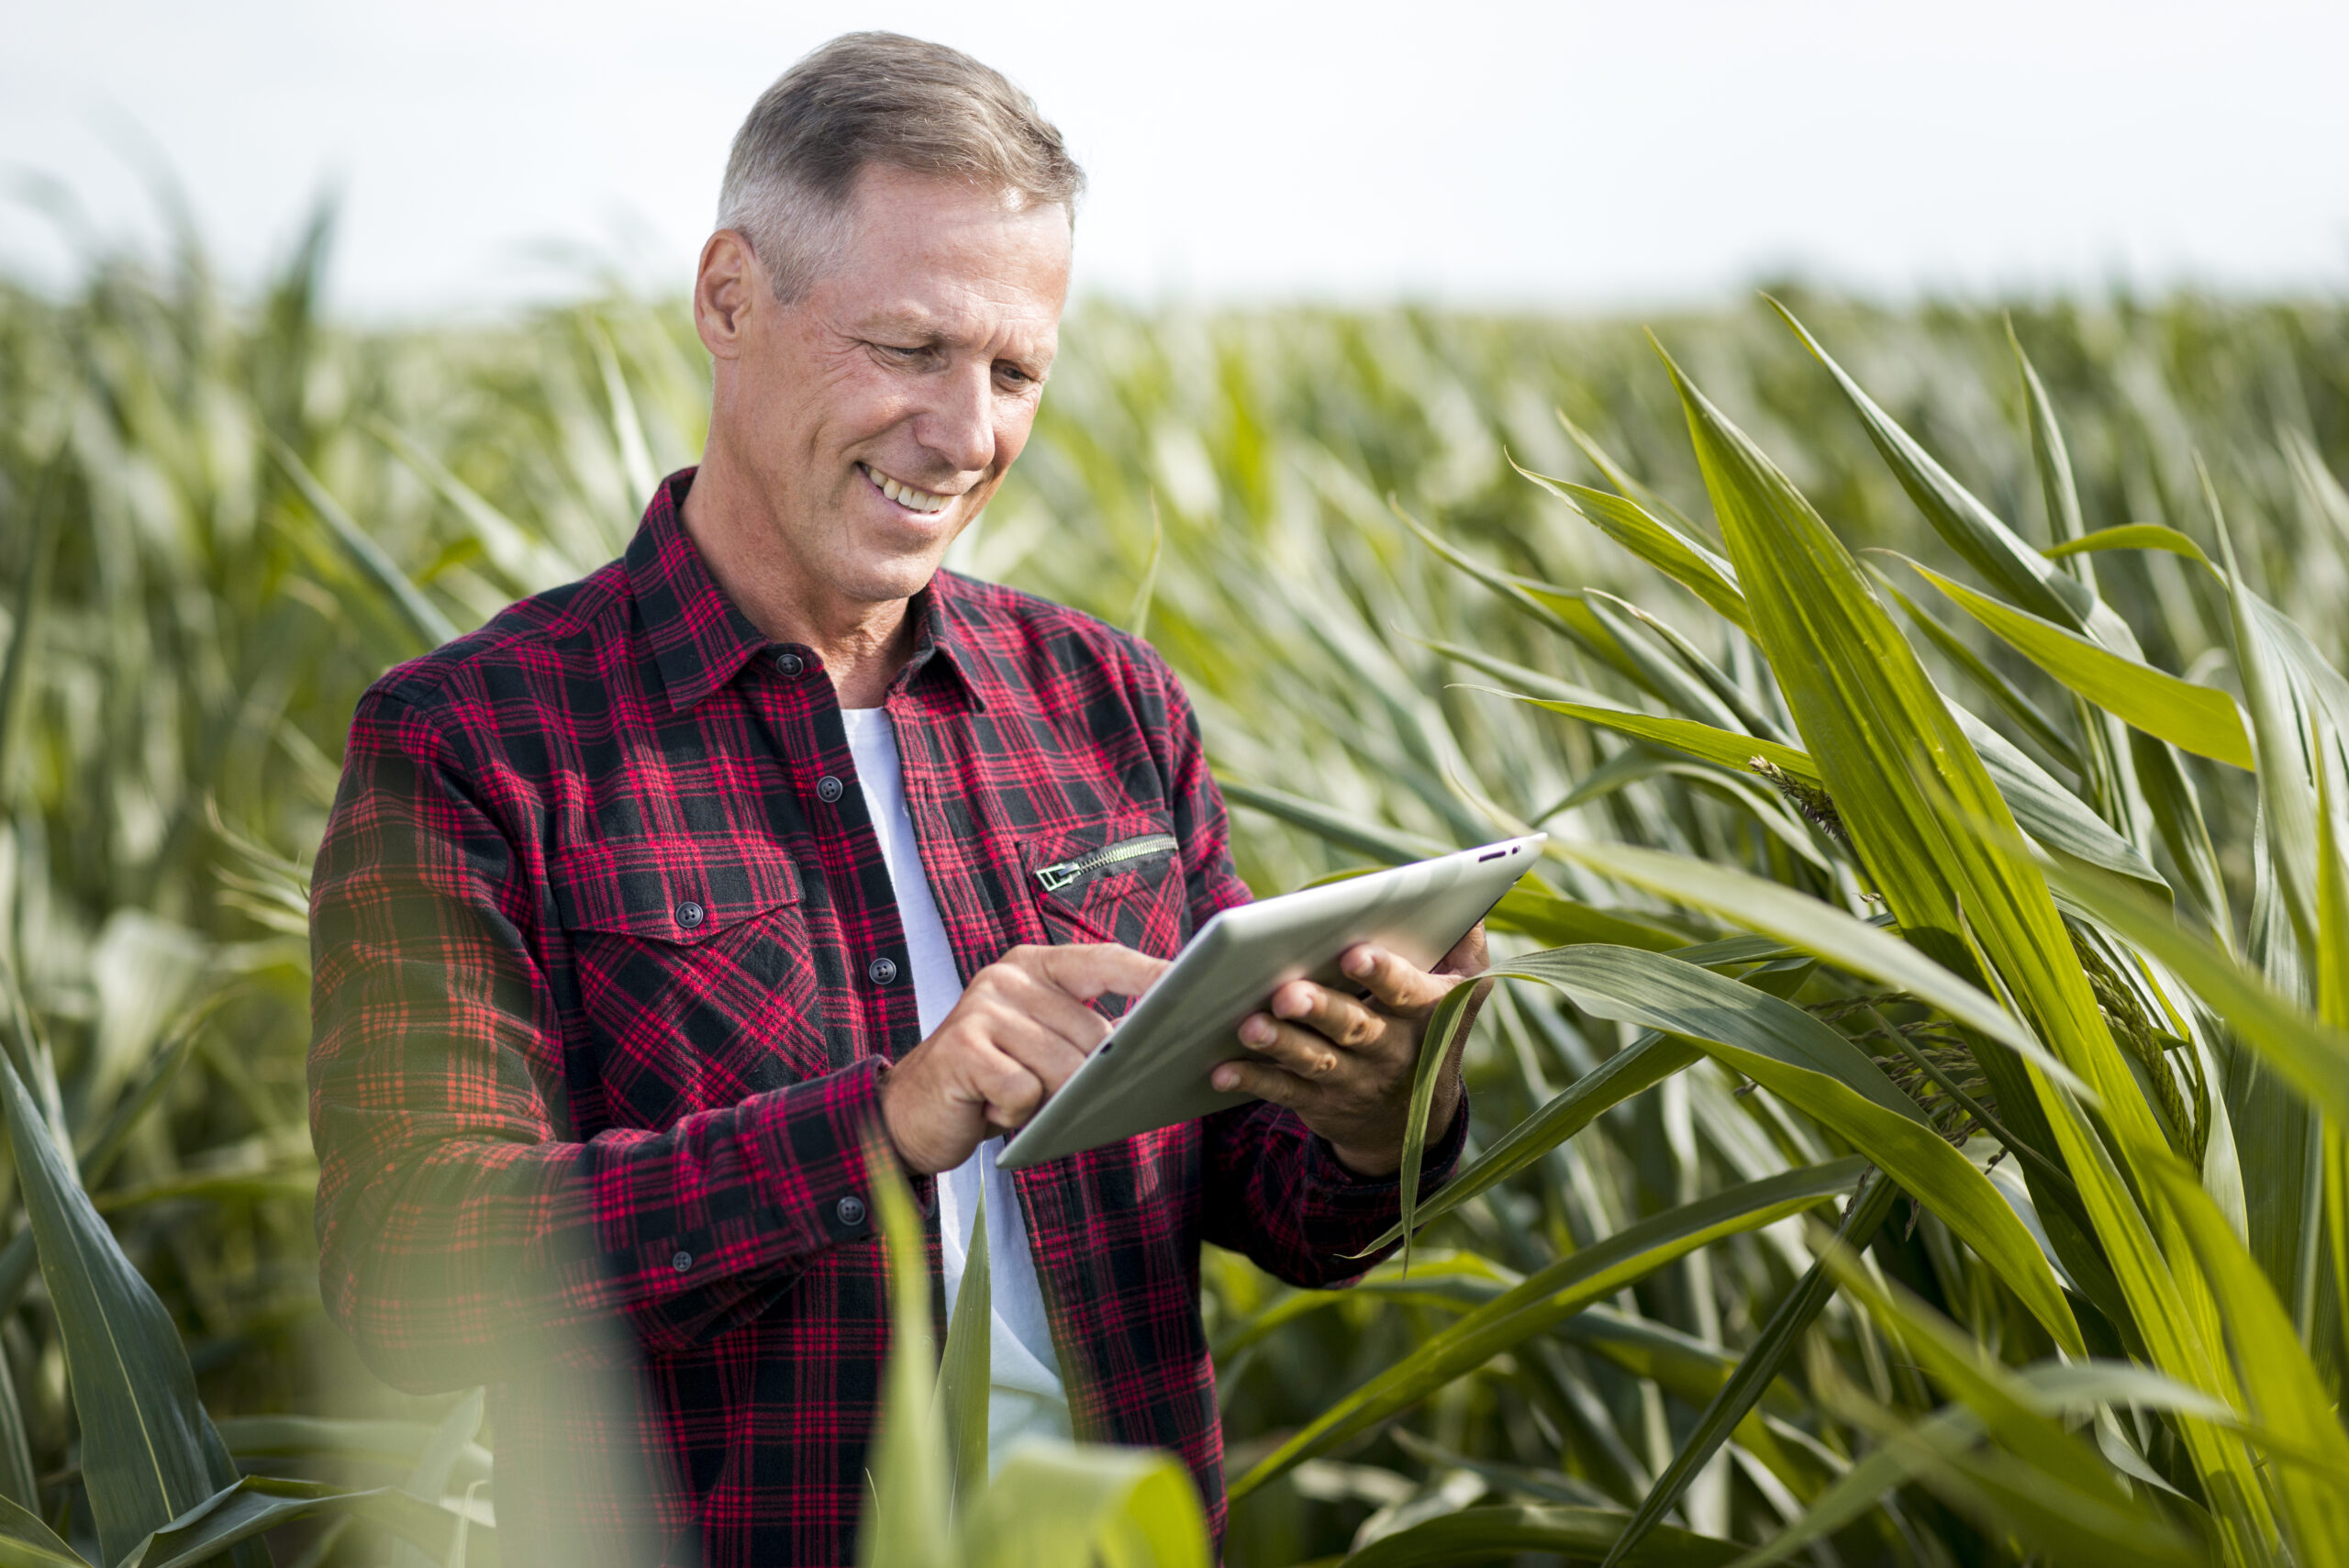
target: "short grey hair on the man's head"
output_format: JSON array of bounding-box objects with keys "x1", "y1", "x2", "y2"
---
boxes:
[{"x1": 718, "y1": 33, "x2": 1085, "y2": 300}]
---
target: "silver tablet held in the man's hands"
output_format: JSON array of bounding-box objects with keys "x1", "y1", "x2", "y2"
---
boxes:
[{"x1": 996, "y1": 833, "x2": 1545, "y2": 1169}]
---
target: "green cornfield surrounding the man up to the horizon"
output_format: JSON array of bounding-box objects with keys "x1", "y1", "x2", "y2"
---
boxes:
[{"x1": 14, "y1": 202, "x2": 2349, "y2": 1568}]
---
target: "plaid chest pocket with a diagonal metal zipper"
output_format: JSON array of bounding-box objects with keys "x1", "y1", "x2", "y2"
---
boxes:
[{"x1": 1019, "y1": 815, "x2": 1191, "y2": 985}]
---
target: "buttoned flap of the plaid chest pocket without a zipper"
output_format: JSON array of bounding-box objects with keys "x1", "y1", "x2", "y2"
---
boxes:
[{"x1": 547, "y1": 838, "x2": 801, "y2": 943}]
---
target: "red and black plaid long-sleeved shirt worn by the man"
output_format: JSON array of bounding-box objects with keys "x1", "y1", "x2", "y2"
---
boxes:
[{"x1": 310, "y1": 470, "x2": 1465, "y2": 1568}]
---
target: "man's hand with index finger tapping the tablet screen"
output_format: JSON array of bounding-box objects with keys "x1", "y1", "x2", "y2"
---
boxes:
[{"x1": 881, "y1": 941, "x2": 1167, "y2": 1176}]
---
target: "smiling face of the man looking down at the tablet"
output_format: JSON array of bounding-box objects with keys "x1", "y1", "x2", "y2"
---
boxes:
[{"x1": 702, "y1": 164, "x2": 1069, "y2": 604}]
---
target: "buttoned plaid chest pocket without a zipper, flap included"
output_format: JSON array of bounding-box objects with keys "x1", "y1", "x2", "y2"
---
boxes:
[{"x1": 550, "y1": 840, "x2": 829, "y2": 1129}]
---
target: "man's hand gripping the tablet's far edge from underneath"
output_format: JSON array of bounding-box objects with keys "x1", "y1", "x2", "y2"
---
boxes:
[{"x1": 1209, "y1": 925, "x2": 1492, "y2": 1176}]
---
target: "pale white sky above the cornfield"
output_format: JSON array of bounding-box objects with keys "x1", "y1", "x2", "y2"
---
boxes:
[{"x1": 0, "y1": 0, "x2": 2349, "y2": 315}]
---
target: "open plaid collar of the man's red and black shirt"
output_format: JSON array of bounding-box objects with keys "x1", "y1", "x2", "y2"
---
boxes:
[{"x1": 628, "y1": 467, "x2": 986, "y2": 714}]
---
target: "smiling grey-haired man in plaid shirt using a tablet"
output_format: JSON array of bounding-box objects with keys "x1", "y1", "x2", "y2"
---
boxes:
[{"x1": 310, "y1": 33, "x2": 1482, "y2": 1568}]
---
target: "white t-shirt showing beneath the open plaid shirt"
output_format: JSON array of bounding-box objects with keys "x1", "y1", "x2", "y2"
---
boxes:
[{"x1": 841, "y1": 709, "x2": 1069, "y2": 1467}]
